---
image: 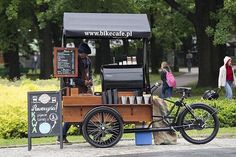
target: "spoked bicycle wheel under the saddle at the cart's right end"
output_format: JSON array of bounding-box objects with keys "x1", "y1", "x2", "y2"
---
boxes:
[{"x1": 179, "y1": 104, "x2": 219, "y2": 144}]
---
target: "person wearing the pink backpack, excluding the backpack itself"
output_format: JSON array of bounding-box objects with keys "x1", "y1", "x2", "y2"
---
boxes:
[{"x1": 161, "y1": 62, "x2": 173, "y2": 98}]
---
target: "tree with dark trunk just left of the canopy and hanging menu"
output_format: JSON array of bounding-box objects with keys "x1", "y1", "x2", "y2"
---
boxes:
[{"x1": 32, "y1": 0, "x2": 66, "y2": 79}]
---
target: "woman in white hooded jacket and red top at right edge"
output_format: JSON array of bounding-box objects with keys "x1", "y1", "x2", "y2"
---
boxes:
[{"x1": 218, "y1": 56, "x2": 236, "y2": 99}]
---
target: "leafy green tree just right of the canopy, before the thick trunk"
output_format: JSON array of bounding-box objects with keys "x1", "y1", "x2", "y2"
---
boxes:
[{"x1": 133, "y1": 0, "x2": 194, "y2": 73}]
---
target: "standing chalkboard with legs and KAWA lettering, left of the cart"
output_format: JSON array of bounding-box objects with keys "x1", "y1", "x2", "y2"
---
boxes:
[{"x1": 28, "y1": 91, "x2": 63, "y2": 151}]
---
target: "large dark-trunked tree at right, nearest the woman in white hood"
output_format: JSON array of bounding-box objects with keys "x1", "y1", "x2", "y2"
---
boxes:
[{"x1": 164, "y1": 0, "x2": 228, "y2": 86}]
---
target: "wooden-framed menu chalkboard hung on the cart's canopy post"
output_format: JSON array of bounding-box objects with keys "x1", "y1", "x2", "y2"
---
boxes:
[{"x1": 54, "y1": 47, "x2": 78, "y2": 77}]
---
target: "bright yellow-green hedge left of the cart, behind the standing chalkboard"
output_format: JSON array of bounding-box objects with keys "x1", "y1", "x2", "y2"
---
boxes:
[{"x1": 0, "y1": 79, "x2": 59, "y2": 138}]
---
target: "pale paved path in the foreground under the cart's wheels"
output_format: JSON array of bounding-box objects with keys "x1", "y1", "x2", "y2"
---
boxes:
[{"x1": 0, "y1": 138, "x2": 236, "y2": 157}]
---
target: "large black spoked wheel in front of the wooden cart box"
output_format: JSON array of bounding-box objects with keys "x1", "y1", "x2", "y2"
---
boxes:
[{"x1": 82, "y1": 106, "x2": 123, "y2": 148}]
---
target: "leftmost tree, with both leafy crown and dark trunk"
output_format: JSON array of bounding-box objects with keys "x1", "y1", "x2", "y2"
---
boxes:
[{"x1": 0, "y1": 0, "x2": 36, "y2": 80}]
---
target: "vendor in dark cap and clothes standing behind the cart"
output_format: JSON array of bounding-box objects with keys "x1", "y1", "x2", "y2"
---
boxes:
[{"x1": 57, "y1": 43, "x2": 93, "y2": 144}]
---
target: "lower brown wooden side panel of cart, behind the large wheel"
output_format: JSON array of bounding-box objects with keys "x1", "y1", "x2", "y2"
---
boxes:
[{"x1": 63, "y1": 104, "x2": 152, "y2": 123}]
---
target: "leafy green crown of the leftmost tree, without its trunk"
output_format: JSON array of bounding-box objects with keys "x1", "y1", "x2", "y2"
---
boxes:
[{"x1": 0, "y1": 0, "x2": 35, "y2": 53}]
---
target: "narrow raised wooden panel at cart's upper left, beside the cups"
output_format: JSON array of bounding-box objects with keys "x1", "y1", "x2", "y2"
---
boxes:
[{"x1": 63, "y1": 95, "x2": 102, "y2": 106}]
